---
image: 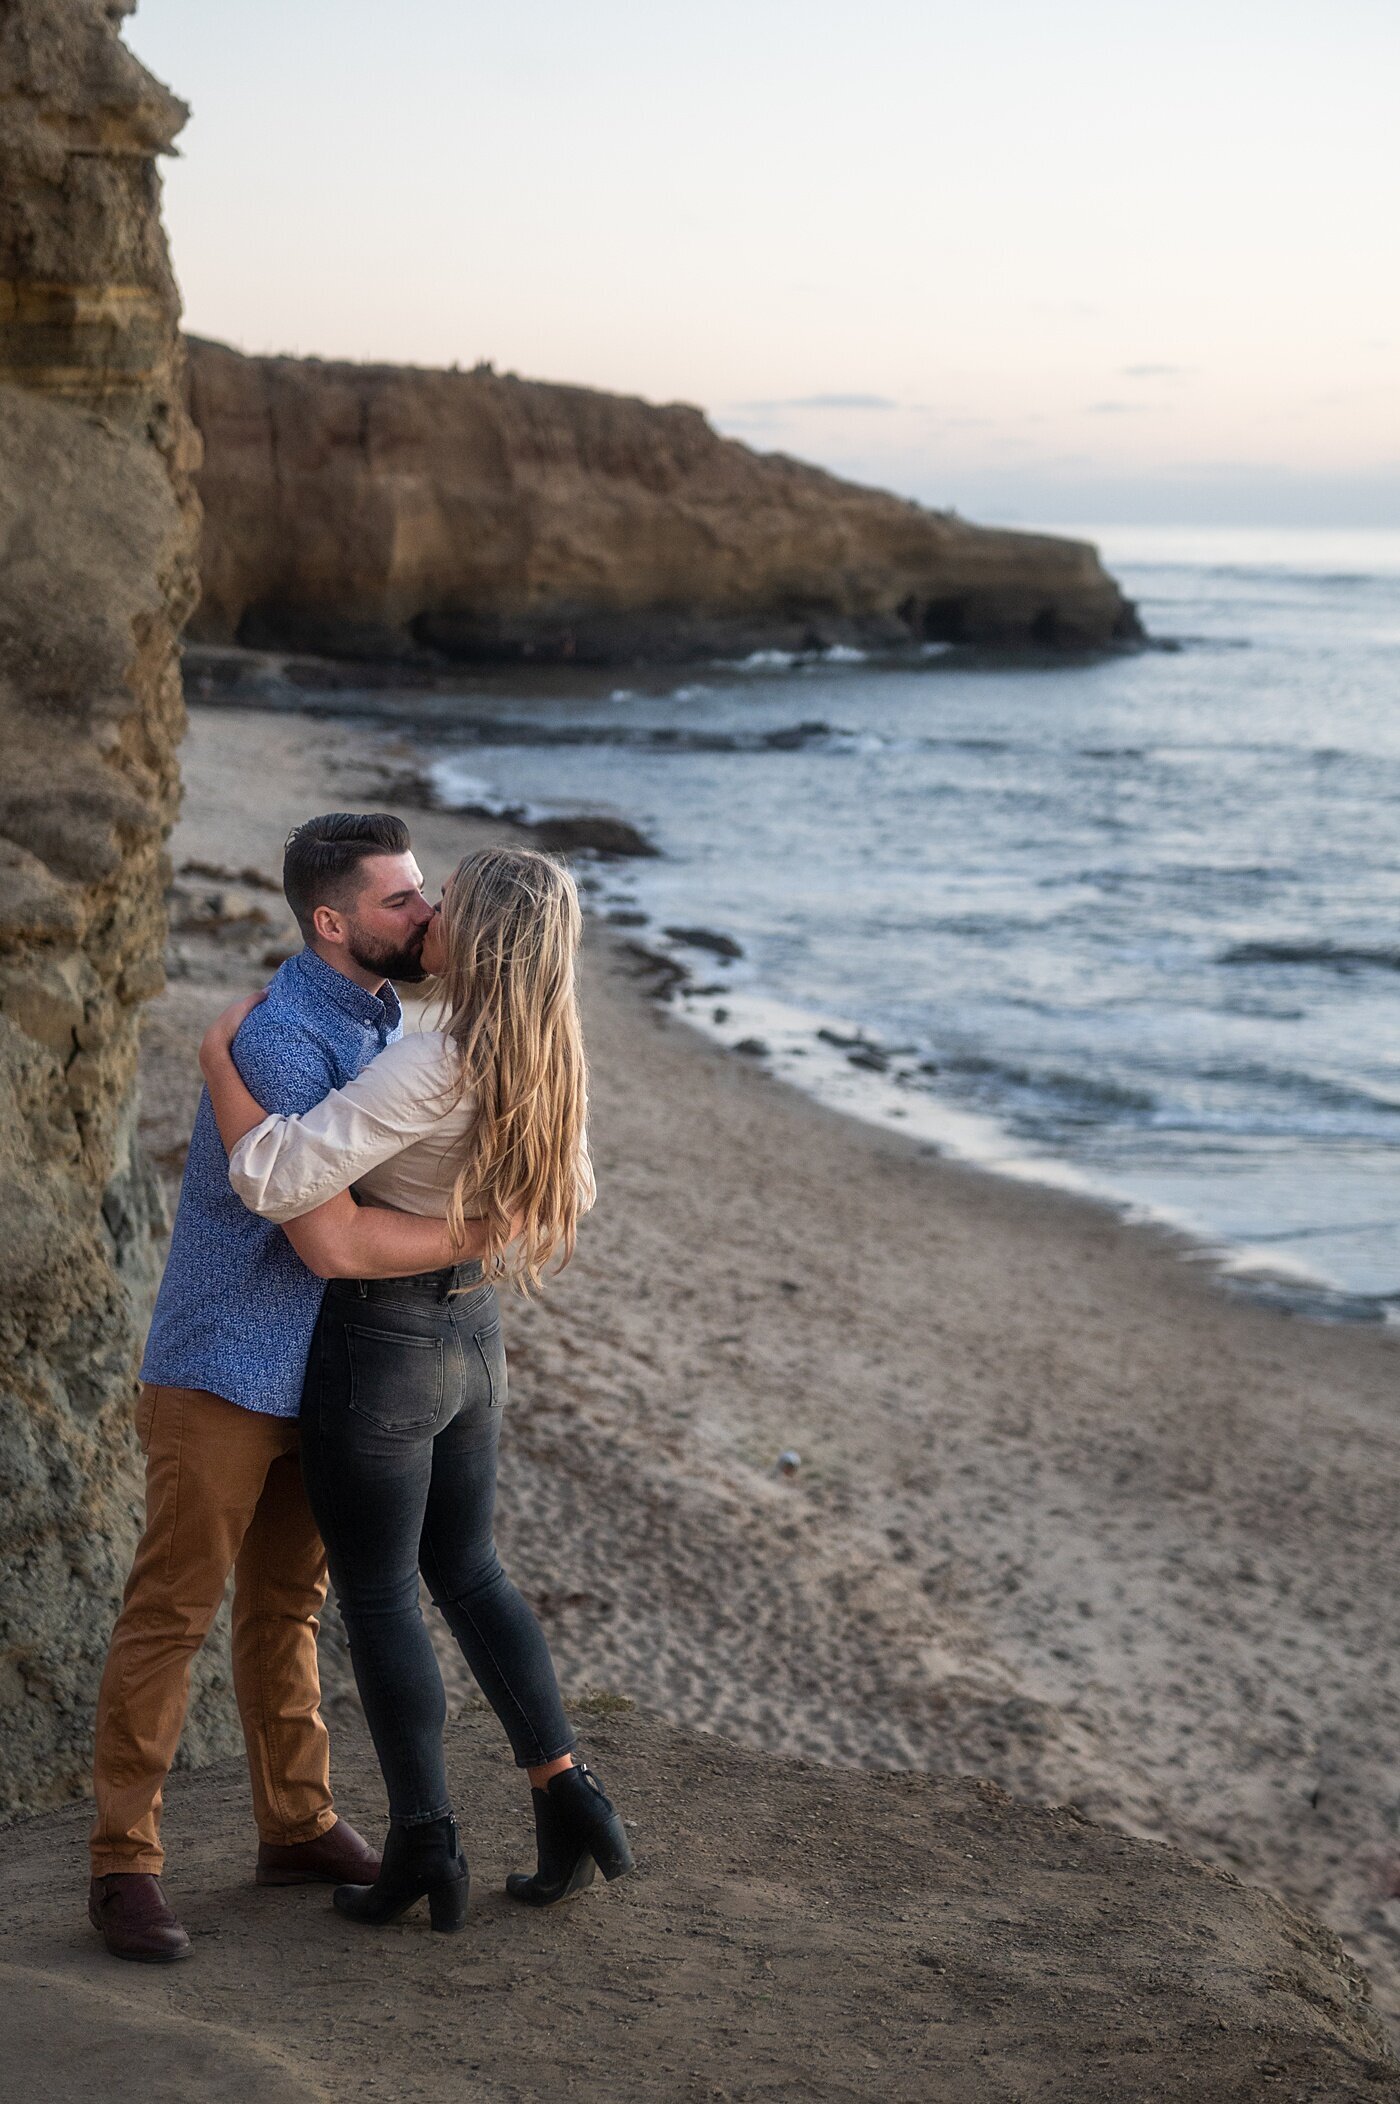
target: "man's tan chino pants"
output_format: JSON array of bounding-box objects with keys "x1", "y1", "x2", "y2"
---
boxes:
[{"x1": 91, "y1": 1387, "x2": 335, "y2": 1877}]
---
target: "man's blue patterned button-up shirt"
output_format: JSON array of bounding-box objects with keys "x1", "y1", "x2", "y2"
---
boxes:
[{"x1": 141, "y1": 949, "x2": 404, "y2": 1418}]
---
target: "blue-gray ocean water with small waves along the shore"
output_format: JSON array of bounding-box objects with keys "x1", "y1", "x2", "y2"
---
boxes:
[{"x1": 423, "y1": 528, "x2": 1400, "y2": 1321}]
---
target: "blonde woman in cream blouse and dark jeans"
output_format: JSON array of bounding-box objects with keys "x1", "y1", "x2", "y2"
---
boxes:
[{"x1": 200, "y1": 848, "x2": 632, "y2": 1929}]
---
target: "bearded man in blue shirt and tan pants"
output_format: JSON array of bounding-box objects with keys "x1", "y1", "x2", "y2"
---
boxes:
[{"x1": 88, "y1": 812, "x2": 472, "y2": 1963}]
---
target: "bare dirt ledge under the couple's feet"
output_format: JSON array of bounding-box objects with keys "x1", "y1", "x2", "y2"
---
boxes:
[{"x1": 0, "y1": 1704, "x2": 1400, "y2": 2104}]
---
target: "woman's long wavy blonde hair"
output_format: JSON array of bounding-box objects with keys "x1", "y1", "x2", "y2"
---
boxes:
[{"x1": 438, "y1": 848, "x2": 592, "y2": 1294}]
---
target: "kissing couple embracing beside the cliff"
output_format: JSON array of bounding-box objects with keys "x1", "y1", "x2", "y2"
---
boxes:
[{"x1": 88, "y1": 812, "x2": 632, "y2": 1963}]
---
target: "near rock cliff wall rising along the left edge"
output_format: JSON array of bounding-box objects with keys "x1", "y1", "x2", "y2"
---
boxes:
[{"x1": 0, "y1": 0, "x2": 210, "y2": 1807}]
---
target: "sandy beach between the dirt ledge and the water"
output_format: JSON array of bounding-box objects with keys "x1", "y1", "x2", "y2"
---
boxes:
[{"x1": 143, "y1": 707, "x2": 1400, "y2": 2022}]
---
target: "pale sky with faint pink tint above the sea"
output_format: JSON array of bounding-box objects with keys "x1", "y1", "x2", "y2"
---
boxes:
[{"x1": 126, "y1": 0, "x2": 1400, "y2": 526}]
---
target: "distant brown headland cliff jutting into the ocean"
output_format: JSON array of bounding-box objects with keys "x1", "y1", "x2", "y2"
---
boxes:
[{"x1": 189, "y1": 341, "x2": 1139, "y2": 663}]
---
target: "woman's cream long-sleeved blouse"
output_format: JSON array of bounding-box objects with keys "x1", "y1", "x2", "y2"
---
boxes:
[{"x1": 229, "y1": 1031, "x2": 594, "y2": 1220}]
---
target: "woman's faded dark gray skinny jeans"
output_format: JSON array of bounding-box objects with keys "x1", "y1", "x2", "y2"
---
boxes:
[{"x1": 301, "y1": 1265, "x2": 575, "y2": 1822}]
